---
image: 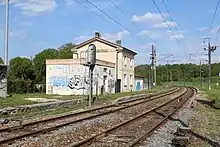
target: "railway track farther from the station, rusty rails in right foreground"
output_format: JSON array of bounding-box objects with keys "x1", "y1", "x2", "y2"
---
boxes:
[{"x1": 70, "y1": 88, "x2": 196, "y2": 147}]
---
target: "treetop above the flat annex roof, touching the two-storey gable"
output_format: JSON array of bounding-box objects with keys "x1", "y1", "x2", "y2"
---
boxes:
[{"x1": 57, "y1": 43, "x2": 76, "y2": 59}]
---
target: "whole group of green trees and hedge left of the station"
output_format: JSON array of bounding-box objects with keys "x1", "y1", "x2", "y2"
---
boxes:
[{"x1": 3, "y1": 43, "x2": 75, "y2": 93}]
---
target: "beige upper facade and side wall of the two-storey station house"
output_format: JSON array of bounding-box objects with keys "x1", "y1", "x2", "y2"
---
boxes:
[{"x1": 73, "y1": 33, "x2": 137, "y2": 92}]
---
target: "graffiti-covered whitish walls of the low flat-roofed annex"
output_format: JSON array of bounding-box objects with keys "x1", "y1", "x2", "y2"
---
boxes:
[{"x1": 47, "y1": 65, "x2": 115, "y2": 94}]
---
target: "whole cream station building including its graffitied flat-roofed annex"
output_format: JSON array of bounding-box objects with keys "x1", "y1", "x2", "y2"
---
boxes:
[{"x1": 46, "y1": 32, "x2": 137, "y2": 95}]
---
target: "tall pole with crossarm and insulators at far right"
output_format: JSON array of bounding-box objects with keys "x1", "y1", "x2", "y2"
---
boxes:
[{"x1": 203, "y1": 38, "x2": 217, "y2": 90}]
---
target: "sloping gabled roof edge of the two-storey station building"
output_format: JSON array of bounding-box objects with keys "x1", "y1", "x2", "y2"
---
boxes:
[{"x1": 75, "y1": 37, "x2": 137, "y2": 55}]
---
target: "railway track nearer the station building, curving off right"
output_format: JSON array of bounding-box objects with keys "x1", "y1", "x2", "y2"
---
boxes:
[{"x1": 0, "y1": 87, "x2": 182, "y2": 144}]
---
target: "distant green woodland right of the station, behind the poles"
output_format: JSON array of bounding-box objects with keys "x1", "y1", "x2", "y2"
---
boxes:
[{"x1": 135, "y1": 63, "x2": 220, "y2": 83}]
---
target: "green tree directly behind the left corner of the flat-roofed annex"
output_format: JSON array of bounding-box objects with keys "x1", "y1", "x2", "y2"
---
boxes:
[{"x1": 33, "y1": 48, "x2": 59, "y2": 84}]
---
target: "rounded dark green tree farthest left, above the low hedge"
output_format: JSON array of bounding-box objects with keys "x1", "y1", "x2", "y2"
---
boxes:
[{"x1": 9, "y1": 57, "x2": 34, "y2": 80}]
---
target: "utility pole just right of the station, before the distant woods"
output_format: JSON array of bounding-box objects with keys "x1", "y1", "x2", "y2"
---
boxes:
[{"x1": 150, "y1": 44, "x2": 157, "y2": 86}]
